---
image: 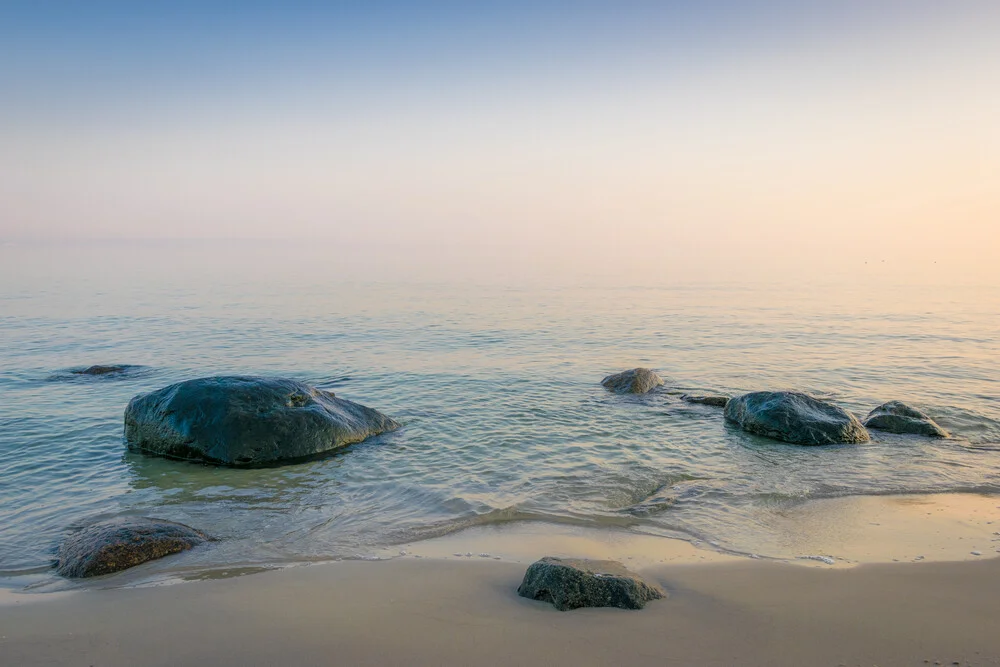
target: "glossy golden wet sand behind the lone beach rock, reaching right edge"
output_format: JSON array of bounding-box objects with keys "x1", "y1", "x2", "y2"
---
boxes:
[{"x1": 390, "y1": 493, "x2": 1000, "y2": 567}]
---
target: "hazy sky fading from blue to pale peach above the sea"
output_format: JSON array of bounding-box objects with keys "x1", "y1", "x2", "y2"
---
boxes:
[{"x1": 0, "y1": 0, "x2": 1000, "y2": 282}]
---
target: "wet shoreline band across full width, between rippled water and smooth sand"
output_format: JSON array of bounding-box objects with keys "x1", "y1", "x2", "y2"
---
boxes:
[{"x1": 0, "y1": 493, "x2": 1000, "y2": 607}]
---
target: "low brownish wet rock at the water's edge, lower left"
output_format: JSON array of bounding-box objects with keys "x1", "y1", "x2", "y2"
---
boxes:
[{"x1": 56, "y1": 517, "x2": 208, "y2": 578}]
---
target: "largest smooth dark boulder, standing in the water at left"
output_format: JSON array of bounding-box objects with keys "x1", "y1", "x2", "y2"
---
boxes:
[{"x1": 125, "y1": 377, "x2": 399, "y2": 466}]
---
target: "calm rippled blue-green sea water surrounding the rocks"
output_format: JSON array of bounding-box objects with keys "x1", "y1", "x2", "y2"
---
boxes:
[{"x1": 0, "y1": 248, "x2": 1000, "y2": 588}]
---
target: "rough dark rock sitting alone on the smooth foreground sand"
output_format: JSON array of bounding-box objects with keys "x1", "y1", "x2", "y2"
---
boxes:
[{"x1": 517, "y1": 557, "x2": 667, "y2": 611}]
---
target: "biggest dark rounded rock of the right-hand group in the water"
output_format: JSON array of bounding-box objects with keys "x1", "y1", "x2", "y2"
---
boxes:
[{"x1": 725, "y1": 391, "x2": 870, "y2": 445}]
